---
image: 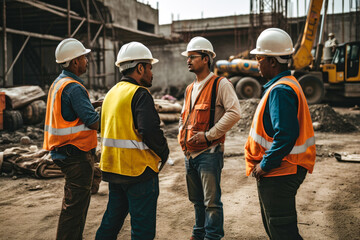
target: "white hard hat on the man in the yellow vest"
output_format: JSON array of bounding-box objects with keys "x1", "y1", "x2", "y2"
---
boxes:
[{"x1": 115, "y1": 42, "x2": 159, "y2": 72}]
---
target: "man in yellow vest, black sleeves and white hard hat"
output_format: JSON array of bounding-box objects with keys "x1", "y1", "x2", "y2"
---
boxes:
[{"x1": 95, "y1": 42, "x2": 169, "y2": 240}]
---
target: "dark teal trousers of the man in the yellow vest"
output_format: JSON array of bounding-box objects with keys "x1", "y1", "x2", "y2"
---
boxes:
[{"x1": 95, "y1": 176, "x2": 159, "y2": 240}]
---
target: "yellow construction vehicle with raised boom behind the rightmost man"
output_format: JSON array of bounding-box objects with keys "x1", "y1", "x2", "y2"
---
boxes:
[{"x1": 214, "y1": 0, "x2": 360, "y2": 104}]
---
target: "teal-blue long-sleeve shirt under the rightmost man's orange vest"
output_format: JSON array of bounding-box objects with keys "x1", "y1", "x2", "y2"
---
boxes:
[{"x1": 260, "y1": 71, "x2": 299, "y2": 172}]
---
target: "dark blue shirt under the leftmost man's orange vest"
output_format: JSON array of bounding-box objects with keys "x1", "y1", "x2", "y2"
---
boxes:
[{"x1": 51, "y1": 70, "x2": 100, "y2": 159}]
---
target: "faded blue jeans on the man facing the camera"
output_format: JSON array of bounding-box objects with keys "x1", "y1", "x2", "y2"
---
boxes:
[{"x1": 185, "y1": 152, "x2": 224, "y2": 240}]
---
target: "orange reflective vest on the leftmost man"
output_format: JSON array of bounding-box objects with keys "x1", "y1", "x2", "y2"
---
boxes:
[{"x1": 43, "y1": 77, "x2": 97, "y2": 152}]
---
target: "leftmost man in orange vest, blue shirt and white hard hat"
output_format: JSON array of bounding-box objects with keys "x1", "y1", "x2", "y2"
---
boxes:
[{"x1": 43, "y1": 38, "x2": 101, "y2": 240}]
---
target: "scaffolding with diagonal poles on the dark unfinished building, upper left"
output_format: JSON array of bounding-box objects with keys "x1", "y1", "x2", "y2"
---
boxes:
[{"x1": 0, "y1": 0, "x2": 164, "y2": 88}]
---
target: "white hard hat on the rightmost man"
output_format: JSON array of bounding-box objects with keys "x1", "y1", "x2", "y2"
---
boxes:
[{"x1": 250, "y1": 28, "x2": 294, "y2": 56}]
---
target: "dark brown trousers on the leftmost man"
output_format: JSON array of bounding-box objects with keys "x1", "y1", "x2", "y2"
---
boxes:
[{"x1": 54, "y1": 152, "x2": 95, "y2": 240}]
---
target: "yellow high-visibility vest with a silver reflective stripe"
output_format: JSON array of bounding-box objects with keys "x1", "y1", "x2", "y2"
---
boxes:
[{"x1": 100, "y1": 81, "x2": 160, "y2": 176}]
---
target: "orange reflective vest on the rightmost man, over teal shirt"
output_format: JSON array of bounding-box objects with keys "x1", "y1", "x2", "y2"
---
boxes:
[{"x1": 245, "y1": 76, "x2": 316, "y2": 177}]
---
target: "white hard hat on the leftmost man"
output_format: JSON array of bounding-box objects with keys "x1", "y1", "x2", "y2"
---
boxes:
[{"x1": 55, "y1": 38, "x2": 91, "y2": 63}]
